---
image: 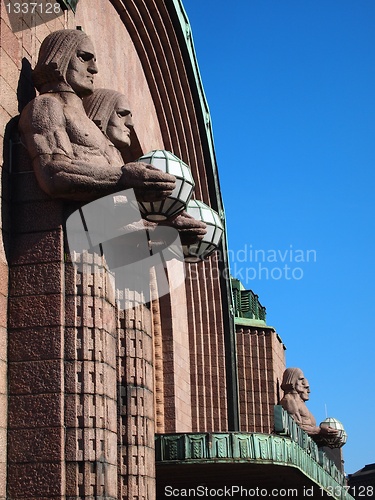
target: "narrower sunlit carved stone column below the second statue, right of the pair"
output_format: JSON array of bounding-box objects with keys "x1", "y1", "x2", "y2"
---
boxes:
[{"x1": 118, "y1": 290, "x2": 155, "y2": 500}]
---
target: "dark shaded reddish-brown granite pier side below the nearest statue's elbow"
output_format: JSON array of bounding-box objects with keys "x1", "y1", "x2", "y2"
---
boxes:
[{"x1": 7, "y1": 144, "x2": 65, "y2": 499}]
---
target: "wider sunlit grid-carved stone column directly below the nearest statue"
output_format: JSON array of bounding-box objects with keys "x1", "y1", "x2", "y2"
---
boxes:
[{"x1": 64, "y1": 254, "x2": 117, "y2": 500}]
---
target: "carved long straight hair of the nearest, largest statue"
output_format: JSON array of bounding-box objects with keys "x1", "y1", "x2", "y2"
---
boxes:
[{"x1": 33, "y1": 30, "x2": 88, "y2": 91}]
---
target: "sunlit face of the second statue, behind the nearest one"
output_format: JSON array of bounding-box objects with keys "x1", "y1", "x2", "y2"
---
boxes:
[{"x1": 106, "y1": 96, "x2": 134, "y2": 149}]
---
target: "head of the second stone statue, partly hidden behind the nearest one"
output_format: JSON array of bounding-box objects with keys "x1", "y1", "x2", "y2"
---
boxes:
[{"x1": 83, "y1": 89, "x2": 133, "y2": 149}]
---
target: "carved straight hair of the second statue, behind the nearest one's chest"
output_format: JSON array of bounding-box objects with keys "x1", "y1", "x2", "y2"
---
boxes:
[{"x1": 83, "y1": 89, "x2": 123, "y2": 134}]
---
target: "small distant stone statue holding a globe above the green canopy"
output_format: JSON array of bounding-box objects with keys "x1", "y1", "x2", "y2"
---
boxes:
[{"x1": 280, "y1": 368, "x2": 337, "y2": 441}]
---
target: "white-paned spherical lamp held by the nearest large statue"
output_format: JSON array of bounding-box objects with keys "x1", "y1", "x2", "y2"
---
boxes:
[{"x1": 137, "y1": 149, "x2": 195, "y2": 222}]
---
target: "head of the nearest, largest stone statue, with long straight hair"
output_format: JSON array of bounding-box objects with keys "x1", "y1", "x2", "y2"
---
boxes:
[{"x1": 33, "y1": 30, "x2": 98, "y2": 97}]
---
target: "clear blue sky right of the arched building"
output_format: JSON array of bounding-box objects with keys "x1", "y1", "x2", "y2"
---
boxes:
[{"x1": 183, "y1": 0, "x2": 375, "y2": 473}]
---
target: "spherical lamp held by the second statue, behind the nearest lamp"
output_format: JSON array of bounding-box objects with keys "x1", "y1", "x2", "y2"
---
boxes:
[{"x1": 183, "y1": 200, "x2": 224, "y2": 263}]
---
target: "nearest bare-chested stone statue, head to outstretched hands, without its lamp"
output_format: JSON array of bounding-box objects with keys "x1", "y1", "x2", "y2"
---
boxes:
[{"x1": 19, "y1": 30, "x2": 175, "y2": 201}]
